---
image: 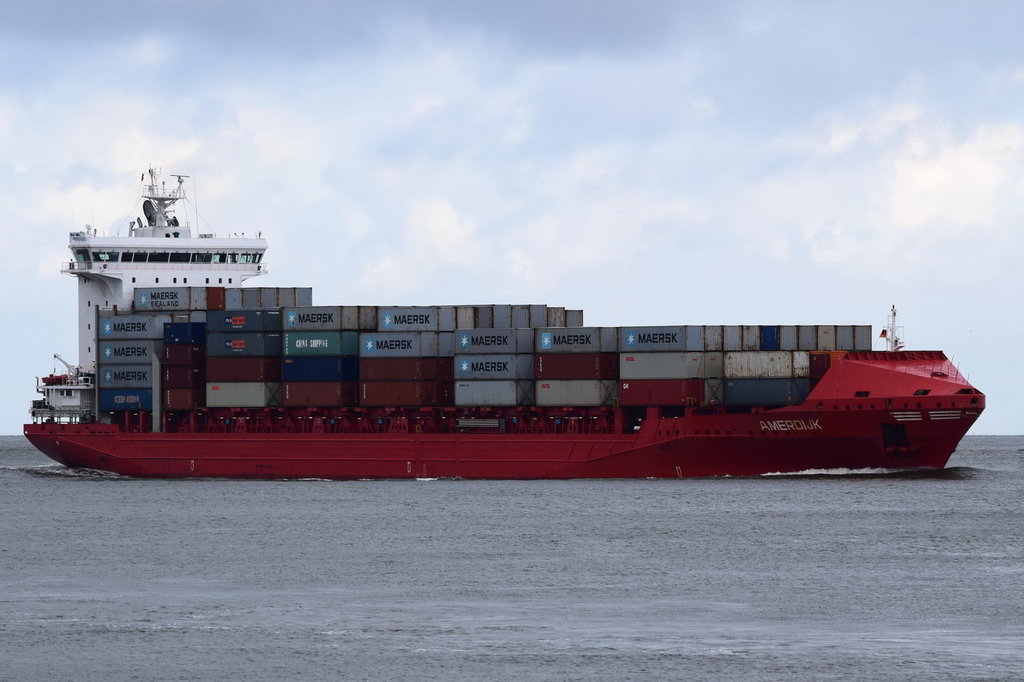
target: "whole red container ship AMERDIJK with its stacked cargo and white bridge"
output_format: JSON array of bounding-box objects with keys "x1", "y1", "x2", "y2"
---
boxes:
[{"x1": 25, "y1": 169, "x2": 985, "y2": 479}]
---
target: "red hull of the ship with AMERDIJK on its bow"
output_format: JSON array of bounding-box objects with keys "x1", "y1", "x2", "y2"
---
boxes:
[{"x1": 25, "y1": 353, "x2": 984, "y2": 479}]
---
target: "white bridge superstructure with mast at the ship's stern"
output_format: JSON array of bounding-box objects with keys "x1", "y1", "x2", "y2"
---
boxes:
[{"x1": 61, "y1": 168, "x2": 266, "y2": 372}]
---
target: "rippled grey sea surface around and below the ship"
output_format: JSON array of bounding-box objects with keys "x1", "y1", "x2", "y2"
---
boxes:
[{"x1": 0, "y1": 436, "x2": 1024, "y2": 681}]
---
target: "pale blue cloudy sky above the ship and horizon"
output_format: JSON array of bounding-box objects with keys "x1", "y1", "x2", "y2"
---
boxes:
[{"x1": 0, "y1": 0, "x2": 1024, "y2": 433}]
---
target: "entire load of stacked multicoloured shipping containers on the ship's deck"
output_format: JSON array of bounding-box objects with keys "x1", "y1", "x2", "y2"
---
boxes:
[{"x1": 97, "y1": 287, "x2": 872, "y2": 414}]
